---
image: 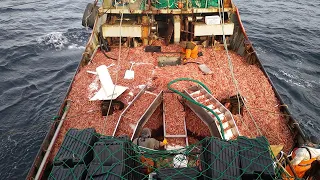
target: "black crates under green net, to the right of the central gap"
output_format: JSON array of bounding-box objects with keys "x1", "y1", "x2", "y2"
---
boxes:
[{"x1": 201, "y1": 137, "x2": 276, "y2": 180}]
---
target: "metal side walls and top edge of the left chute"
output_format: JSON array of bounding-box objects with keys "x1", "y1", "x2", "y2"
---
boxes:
[{"x1": 112, "y1": 86, "x2": 163, "y2": 140}]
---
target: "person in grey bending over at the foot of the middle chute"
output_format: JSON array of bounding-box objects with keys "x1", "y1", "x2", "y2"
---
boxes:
[{"x1": 133, "y1": 128, "x2": 168, "y2": 149}]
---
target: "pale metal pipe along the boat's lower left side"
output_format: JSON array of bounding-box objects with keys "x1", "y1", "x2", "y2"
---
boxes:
[{"x1": 34, "y1": 100, "x2": 71, "y2": 180}]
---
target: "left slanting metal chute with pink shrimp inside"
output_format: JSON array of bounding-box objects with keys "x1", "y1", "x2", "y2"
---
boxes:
[{"x1": 112, "y1": 86, "x2": 163, "y2": 140}]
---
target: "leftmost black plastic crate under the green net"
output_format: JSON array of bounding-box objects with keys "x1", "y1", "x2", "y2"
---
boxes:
[{"x1": 53, "y1": 128, "x2": 97, "y2": 166}]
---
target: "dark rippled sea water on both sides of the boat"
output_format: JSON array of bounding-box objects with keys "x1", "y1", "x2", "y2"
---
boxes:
[{"x1": 0, "y1": 0, "x2": 320, "y2": 179}]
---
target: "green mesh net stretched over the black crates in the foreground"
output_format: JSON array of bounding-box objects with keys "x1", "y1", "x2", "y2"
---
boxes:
[{"x1": 47, "y1": 128, "x2": 290, "y2": 180}]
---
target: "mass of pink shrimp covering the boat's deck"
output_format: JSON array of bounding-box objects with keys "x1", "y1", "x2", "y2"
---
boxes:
[{"x1": 50, "y1": 41, "x2": 294, "y2": 159}]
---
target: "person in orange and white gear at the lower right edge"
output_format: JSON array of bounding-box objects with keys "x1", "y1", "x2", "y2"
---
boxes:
[{"x1": 286, "y1": 136, "x2": 320, "y2": 178}]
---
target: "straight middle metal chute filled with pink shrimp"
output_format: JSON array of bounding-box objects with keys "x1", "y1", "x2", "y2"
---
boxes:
[{"x1": 163, "y1": 93, "x2": 189, "y2": 146}]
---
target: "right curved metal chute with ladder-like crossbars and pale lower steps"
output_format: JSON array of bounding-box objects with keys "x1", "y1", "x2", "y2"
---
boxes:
[{"x1": 184, "y1": 86, "x2": 240, "y2": 140}]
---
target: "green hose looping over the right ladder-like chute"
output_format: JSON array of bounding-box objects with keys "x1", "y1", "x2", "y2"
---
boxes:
[{"x1": 167, "y1": 78, "x2": 226, "y2": 140}]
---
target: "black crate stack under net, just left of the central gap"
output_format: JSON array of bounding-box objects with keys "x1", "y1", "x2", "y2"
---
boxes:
[{"x1": 87, "y1": 136, "x2": 139, "y2": 180}]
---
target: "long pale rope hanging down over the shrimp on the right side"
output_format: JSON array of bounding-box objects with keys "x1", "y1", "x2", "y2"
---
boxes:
[{"x1": 219, "y1": 0, "x2": 262, "y2": 135}]
